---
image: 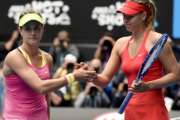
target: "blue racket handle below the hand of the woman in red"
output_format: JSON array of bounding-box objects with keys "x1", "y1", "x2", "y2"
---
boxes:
[{"x1": 118, "y1": 91, "x2": 133, "y2": 114}]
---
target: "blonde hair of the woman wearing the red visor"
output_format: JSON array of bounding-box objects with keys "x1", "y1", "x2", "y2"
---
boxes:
[{"x1": 130, "y1": 0, "x2": 157, "y2": 27}]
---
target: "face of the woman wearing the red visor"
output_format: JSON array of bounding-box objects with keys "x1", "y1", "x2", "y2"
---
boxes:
[{"x1": 123, "y1": 12, "x2": 144, "y2": 32}]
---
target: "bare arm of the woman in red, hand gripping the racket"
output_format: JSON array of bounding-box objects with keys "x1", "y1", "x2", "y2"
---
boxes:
[{"x1": 130, "y1": 39, "x2": 180, "y2": 92}]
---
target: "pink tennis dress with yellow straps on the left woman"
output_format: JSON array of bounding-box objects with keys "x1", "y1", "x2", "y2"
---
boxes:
[{"x1": 3, "y1": 48, "x2": 50, "y2": 120}]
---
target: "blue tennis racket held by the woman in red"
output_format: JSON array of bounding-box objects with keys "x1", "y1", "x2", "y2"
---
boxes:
[{"x1": 118, "y1": 34, "x2": 168, "y2": 113}]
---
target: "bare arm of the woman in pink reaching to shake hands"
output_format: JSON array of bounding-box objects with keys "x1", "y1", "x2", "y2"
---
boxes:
[{"x1": 3, "y1": 50, "x2": 96, "y2": 93}]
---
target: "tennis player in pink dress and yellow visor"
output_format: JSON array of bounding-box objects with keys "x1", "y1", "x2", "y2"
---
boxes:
[{"x1": 3, "y1": 10, "x2": 97, "y2": 120}]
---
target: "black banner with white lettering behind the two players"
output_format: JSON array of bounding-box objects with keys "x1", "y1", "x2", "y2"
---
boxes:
[{"x1": 0, "y1": 0, "x2": 179, "y2": 43}]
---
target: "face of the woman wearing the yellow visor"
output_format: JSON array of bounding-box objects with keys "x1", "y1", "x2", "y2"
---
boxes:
[{"x1": 19, "y1": 21, "x2": 44, "y2": 46}]
